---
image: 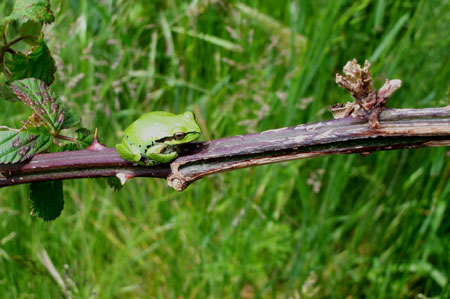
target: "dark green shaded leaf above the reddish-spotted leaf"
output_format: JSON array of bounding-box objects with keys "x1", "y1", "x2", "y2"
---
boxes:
[{"x1": 6, "y1": 39, "x2": 56, "y2": 85}]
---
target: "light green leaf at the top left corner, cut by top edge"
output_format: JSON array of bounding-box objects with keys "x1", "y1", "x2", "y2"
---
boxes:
[{"x1": 3, "y1": 0, "x2": 55, "y2": 24}]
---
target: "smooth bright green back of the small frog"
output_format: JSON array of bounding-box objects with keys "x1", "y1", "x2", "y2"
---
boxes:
[{"x1": 125, "y1": 111, "x2": 176, "y2": 145}]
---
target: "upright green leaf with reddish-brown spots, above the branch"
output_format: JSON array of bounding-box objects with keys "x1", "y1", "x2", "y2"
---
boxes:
[{"x1": 11, "y1": 78, "x2": 66, "y2": 134}]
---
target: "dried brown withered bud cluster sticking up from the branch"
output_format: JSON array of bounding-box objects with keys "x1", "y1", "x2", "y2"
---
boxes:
[{"x1": 328, "y1": 59, "x2": 402, "y2": 129}]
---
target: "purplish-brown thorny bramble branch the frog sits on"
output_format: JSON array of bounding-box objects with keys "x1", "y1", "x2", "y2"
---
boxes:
[{"x1": 0, "y1": 106, "x2": 450, "y2": 191}]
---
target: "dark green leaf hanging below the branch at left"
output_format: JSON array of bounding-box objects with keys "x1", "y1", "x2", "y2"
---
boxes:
[{"x1": 30, "y1": 181, "x2": 64, "y2": 221}]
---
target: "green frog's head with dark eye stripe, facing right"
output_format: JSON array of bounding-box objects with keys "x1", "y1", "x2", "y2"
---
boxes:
[{"x1": 169, "y1": 111, "x2": 201, "y2": 144}]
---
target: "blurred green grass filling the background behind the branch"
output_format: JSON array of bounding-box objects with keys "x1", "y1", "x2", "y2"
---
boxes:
[{"x1": 0, "y1": 0, "x2": 450, "y2": 298}]
